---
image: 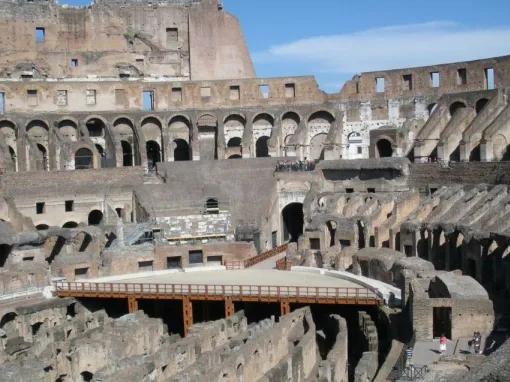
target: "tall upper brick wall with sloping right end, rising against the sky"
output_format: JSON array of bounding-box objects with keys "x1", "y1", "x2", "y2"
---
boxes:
[{"x1": 0, "y1": 0, "x2": 254, "y2": 80}]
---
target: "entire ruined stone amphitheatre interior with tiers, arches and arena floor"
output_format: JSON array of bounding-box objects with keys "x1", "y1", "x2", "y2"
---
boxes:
[{"x1": 0, "y1": 0, "x2": 510, "y2": 382}]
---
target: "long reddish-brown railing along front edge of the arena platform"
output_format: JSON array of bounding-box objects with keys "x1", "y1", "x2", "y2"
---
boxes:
[{"x1": 55, "y1": 281, "x2": 379, "y2": 302}]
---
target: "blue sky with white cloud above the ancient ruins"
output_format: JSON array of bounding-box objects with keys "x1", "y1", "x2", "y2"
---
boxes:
[{"x1": 61, "y1": 0, "x2": 510, "y2": 91}]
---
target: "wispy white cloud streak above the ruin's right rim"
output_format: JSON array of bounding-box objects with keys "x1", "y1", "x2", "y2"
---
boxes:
[{"x1": 254, "y1": 21, "x2": 510, "y2": 74}]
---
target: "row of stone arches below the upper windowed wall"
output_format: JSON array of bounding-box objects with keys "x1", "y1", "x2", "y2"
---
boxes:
[{"x1": 0, "y1": 111, "x2": 335, "y2": 170}]
